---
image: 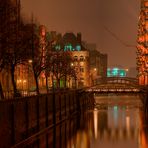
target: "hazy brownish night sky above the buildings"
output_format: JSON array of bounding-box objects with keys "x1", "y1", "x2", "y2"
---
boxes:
[{"x1": 21, "y1": 0, "x2": 140, "y2": 68}]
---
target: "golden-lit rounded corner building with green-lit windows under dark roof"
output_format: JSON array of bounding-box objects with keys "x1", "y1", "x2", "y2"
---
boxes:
[{"x1": 54, "y1": 32, "x2": 90, "y2": 87}]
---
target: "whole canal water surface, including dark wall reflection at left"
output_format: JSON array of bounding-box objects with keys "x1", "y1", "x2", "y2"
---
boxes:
[{"x1": 19, "y1": 94, "x2": 148, "y2": 148}]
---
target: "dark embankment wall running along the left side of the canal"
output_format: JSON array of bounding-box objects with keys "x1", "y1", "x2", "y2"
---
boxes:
[{"x1": 0, "y1": 91, "x2": 94, "y2": 148}]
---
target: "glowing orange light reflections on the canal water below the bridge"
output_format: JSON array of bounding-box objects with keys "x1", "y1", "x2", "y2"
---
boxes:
[{"x1": 67, "y1": 96, "x2": 148, "y2": 148}]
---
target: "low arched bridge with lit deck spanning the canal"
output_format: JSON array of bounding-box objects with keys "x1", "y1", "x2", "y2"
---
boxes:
[{"x1": 86, "y1": 77, "x2": 141, "y2": 93}]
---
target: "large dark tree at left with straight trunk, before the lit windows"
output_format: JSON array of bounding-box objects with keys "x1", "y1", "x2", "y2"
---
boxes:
[{"x1": 2, "y1": 24, "x2": 33, "y2": 96}]
